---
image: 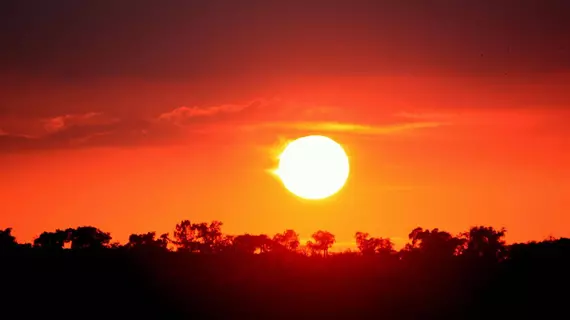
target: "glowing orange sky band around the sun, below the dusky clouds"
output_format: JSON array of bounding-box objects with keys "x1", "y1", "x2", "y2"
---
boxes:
[{"x1": 0, "y1": 74, "x2": 570, "y2": 248}]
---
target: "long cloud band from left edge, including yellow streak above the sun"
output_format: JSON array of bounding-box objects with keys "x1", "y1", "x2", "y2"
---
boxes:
[{"x1": 0, "y1": 99, "x2": 447, "y2": 152}]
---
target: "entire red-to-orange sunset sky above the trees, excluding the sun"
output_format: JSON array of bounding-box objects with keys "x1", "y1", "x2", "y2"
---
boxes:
[{"x1": 0, "y1": 0, "x2": 570, "y2": 246}]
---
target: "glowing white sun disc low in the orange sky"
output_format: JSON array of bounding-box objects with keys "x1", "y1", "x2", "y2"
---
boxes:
[{"x1": 275, "y1": 135, "x2": 350, "y2": 200}]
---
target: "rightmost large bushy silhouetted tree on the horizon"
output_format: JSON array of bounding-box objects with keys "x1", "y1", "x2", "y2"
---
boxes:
[{"x1": 463, "y1": 226, "x2": 507, "y2": 260}]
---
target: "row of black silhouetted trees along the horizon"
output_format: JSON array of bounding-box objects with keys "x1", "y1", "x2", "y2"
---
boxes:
[{"x1": 0, "y1": 220, "x2": 570, "y2": 262}]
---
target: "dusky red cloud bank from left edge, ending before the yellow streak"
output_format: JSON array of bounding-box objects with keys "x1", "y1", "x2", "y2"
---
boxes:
[{"x1": 0, "y1": 100, "x2": 269, "y2": 152}]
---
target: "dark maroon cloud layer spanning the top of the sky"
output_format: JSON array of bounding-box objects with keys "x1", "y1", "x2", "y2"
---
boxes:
[{"x1": 0, "y1": 0, "x2": 570, "y2": 80}]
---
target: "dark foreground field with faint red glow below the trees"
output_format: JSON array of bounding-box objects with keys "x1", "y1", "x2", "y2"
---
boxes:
[{"x1": 0, "y1": 249, "x2": 570, "y2": 319}]
